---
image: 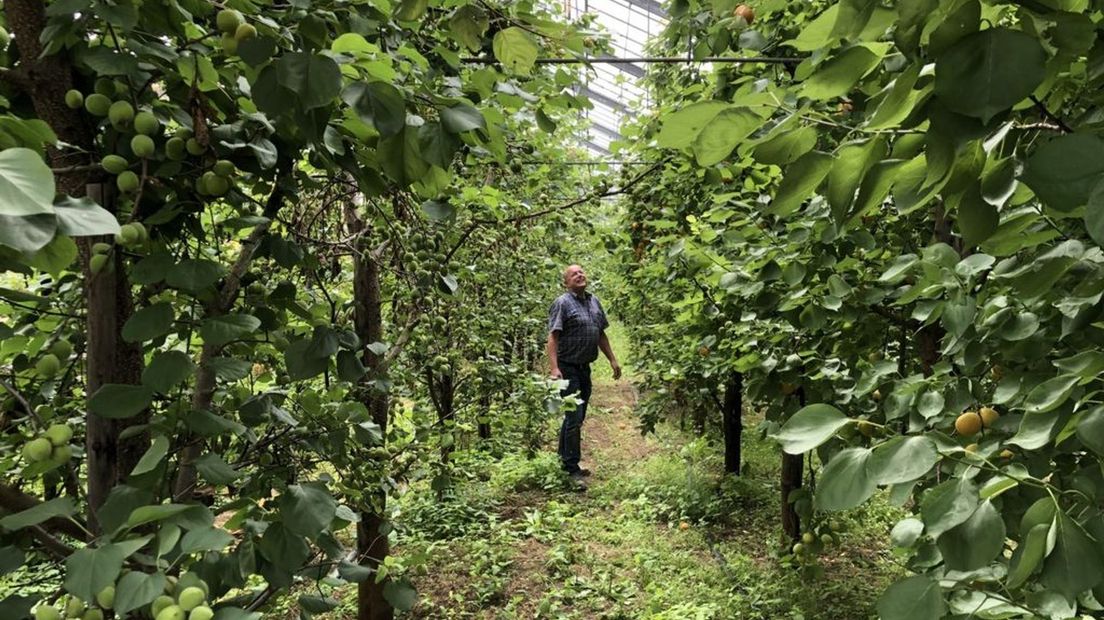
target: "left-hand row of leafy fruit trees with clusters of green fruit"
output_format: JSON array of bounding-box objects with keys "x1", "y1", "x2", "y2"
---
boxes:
[{"x1": 0, "y1": 0, "x2": 613, "y2": 620}]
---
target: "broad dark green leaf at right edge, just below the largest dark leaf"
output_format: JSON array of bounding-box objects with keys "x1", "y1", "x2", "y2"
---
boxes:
[{"x1": 1021, "y1": 133, "x2": 1104, "y2": 212}]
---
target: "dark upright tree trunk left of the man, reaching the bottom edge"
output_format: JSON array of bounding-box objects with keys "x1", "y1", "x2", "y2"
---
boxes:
[{"x1": 347, "y1": 206, "x2": 395, "y2": 620}]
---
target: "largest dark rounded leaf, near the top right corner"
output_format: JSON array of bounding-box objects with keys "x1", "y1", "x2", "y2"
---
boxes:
[{"x1": 935, "y1": 28, "x2": 1047, "y2": 124}]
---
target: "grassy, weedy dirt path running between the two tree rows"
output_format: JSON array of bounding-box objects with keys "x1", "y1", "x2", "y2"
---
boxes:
[{"x1": 401, "y1": 380, "x2": 896, "y2": 620}]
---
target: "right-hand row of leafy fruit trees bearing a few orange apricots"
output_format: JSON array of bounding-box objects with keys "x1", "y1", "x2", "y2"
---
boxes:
[{"x1": 620, "y1": 0, "x2": 1104, "y2": 620}]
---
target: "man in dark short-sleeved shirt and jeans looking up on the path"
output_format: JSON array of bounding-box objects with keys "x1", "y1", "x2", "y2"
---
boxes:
[{"x1": 548, "y1": 265, "x2": 620, "y2": 490}]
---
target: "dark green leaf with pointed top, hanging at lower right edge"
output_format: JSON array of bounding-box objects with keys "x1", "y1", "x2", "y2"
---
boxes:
[{"x1": 1041, "y1": 512, "x2": 1104, "y2": 600}]
